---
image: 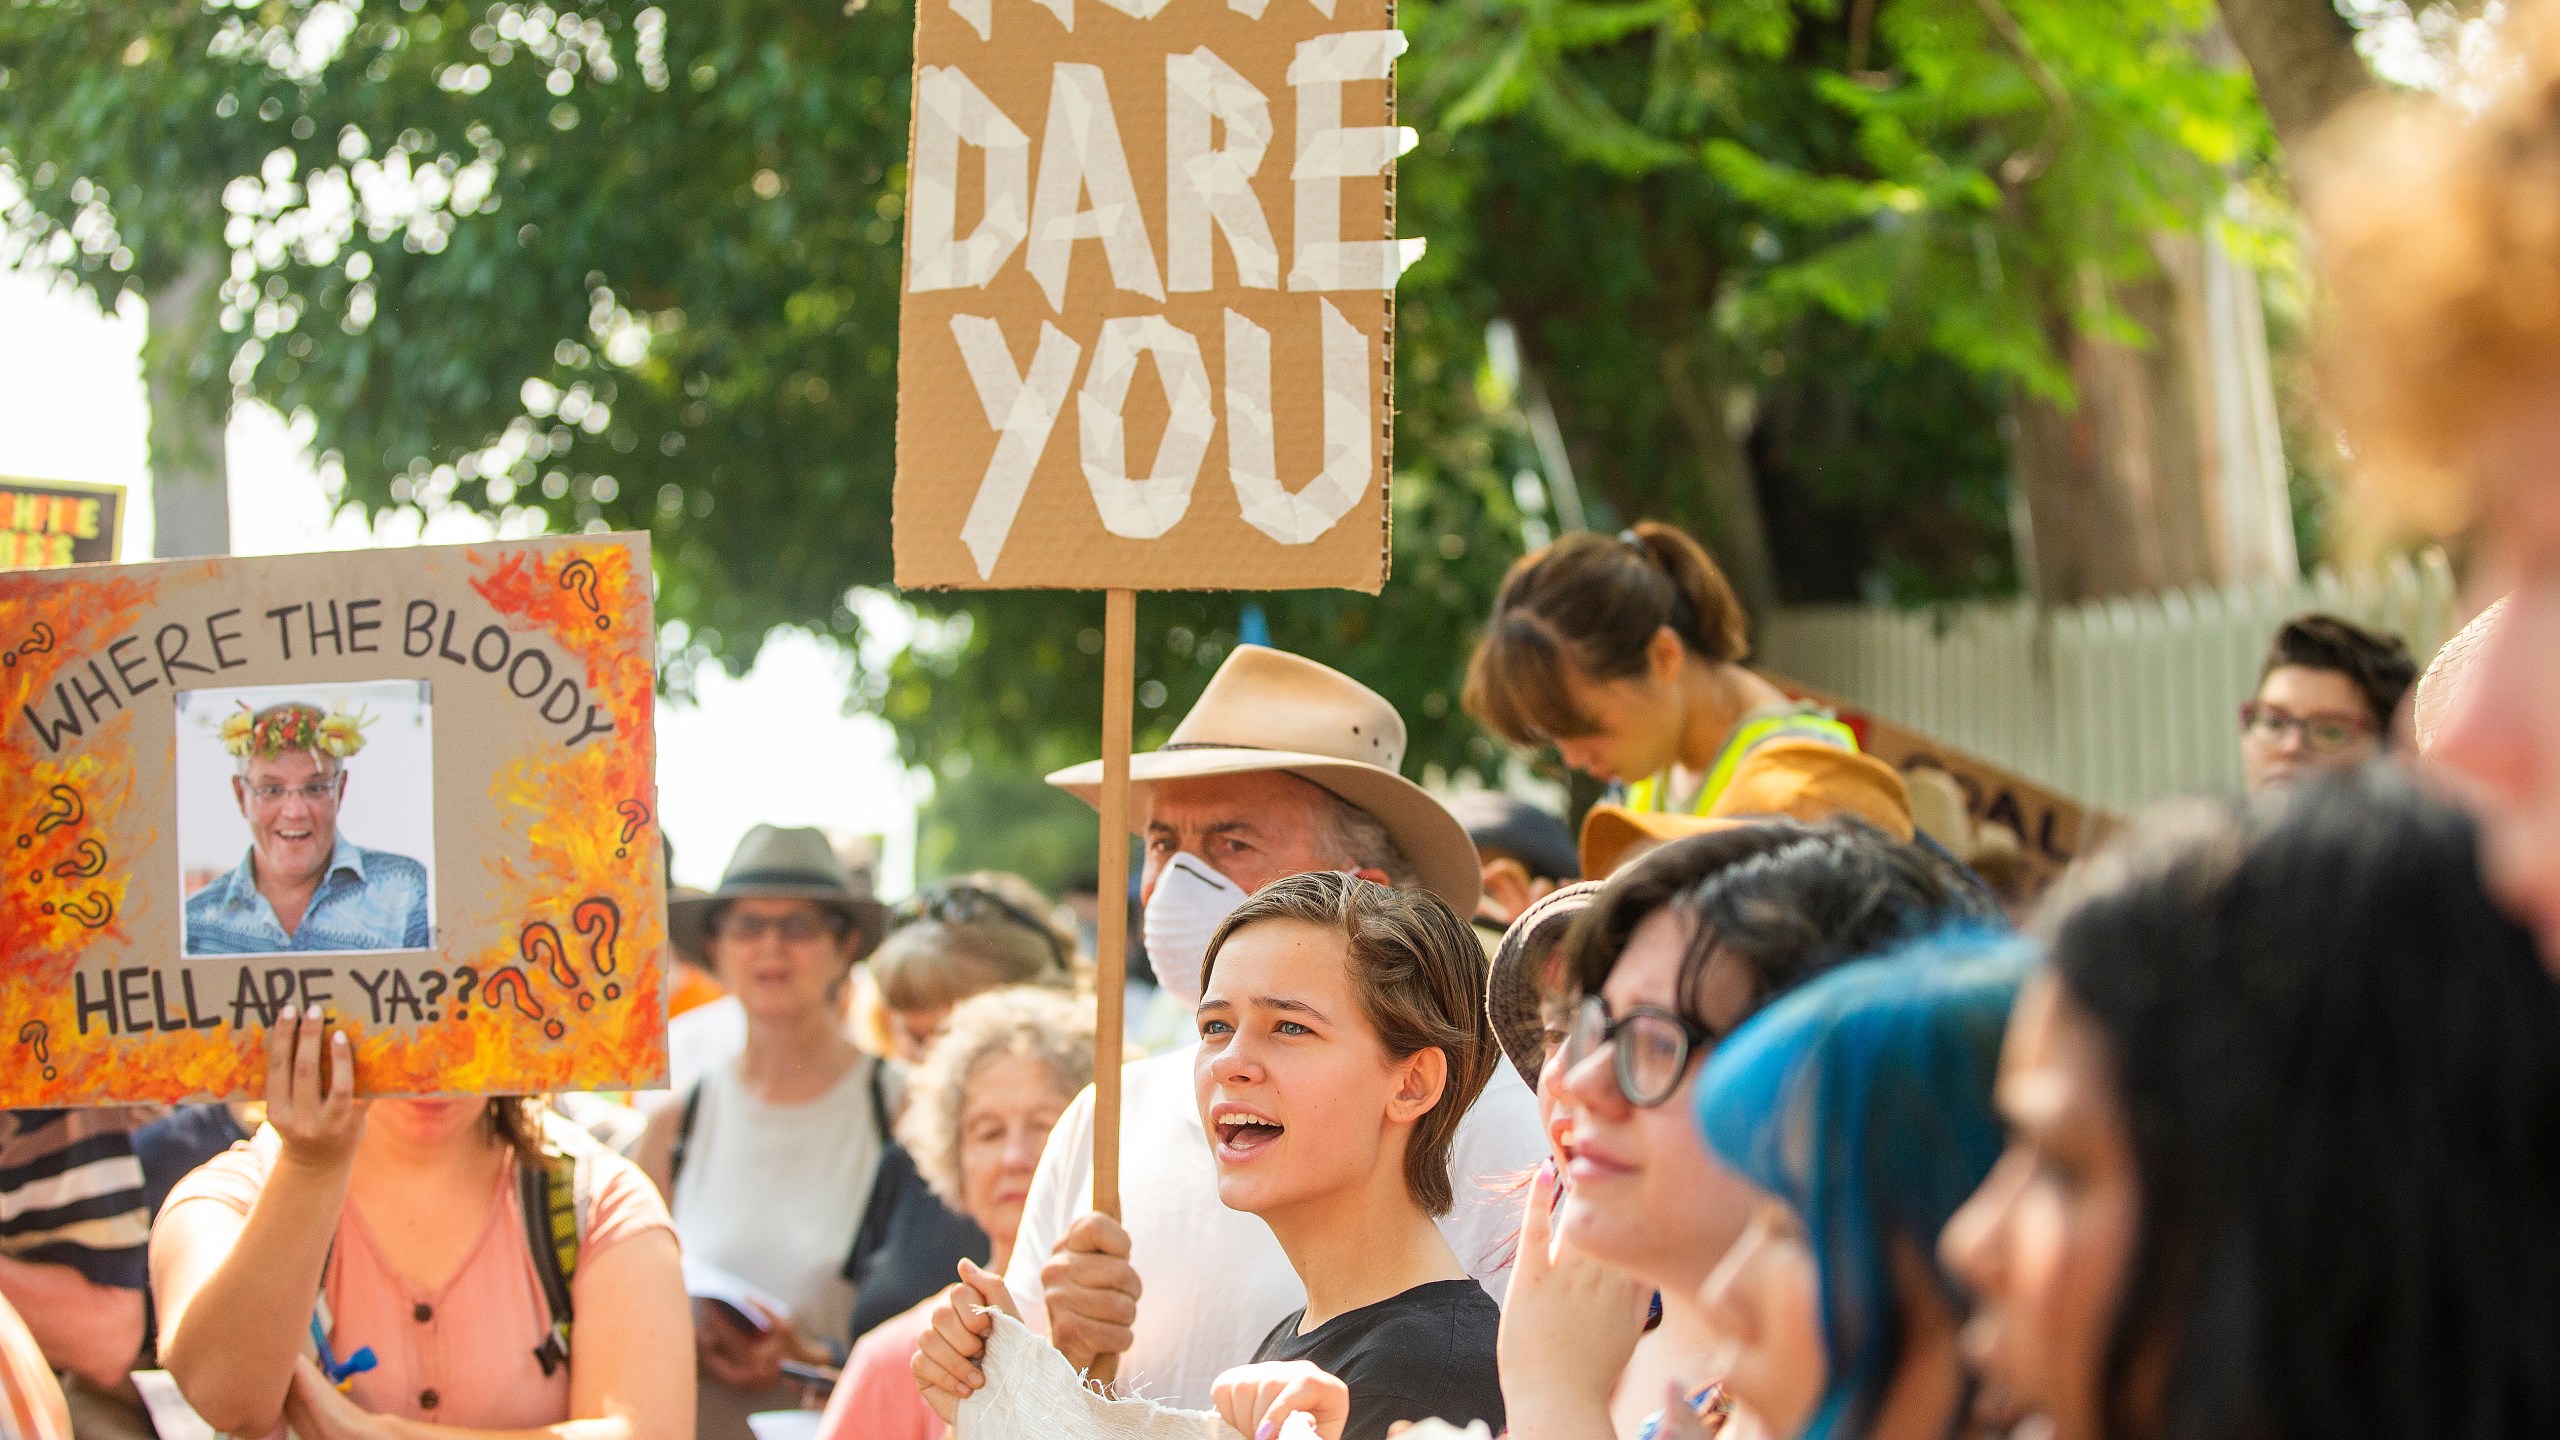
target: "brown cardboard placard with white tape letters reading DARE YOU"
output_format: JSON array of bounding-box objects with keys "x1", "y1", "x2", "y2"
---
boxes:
[{"x1": 896, "y1": 0, "x2": 1421, "y2": 594}]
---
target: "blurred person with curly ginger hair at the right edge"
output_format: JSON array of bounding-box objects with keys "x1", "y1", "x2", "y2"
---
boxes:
[{"x1": 2307, "y1": 0, "x2": 2560, "y2": 971}]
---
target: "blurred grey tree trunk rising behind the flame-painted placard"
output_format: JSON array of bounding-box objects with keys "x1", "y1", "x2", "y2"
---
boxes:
[{"x1": 143, "y1": 251, "x2": 230, "y2": 559}]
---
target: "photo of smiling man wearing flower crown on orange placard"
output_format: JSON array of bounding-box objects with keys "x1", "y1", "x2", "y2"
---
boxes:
[{"x1": 182, "y1": 687, "x2": 433, "y2": 956}]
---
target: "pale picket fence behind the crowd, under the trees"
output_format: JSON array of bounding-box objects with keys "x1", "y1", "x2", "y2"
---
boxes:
[{"x1": 1756, "y1": 551, "x2": 2458, "y2": 815}]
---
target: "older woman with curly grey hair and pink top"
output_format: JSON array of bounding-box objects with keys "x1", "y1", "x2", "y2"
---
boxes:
[{"x1": 819, "y1": 986, "x2": 1093, "y2": 1440}]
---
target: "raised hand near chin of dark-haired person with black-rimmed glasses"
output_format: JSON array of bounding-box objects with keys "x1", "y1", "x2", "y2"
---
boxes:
[{"x1": 1495, "y1": 1161, "x2": 1651, "y2": 1435}]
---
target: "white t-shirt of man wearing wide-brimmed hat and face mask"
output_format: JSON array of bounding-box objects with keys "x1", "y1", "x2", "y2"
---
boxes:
[{"x1": 1004, "y1": 1040, "x2": 1546, "y2": 1409}]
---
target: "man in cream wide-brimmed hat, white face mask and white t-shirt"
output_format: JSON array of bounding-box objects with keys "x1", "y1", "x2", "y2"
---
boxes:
[{"x1": 916, "y1": 646, "x2": 1546, "y2": 1409}]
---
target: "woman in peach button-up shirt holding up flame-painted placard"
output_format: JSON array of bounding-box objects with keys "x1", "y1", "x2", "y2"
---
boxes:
[{"x1": 151, "y1": 1010, "x2": 694, "y2": 1440}]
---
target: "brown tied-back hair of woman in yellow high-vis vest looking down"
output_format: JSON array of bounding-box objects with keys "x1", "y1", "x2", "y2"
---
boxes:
[{"x1": 1459, "y1": 520, "x2": 1751, "y2": 746}]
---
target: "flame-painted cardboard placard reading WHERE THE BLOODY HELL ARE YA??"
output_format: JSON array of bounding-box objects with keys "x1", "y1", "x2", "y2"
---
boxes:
[{"x1": 0, "y1": 536, "x2": 666, "y2": 1107}]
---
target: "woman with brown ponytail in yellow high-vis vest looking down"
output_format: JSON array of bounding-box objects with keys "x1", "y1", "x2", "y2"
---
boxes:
[{"x1": 1464, "y1": 520, "x2": 1859, "y2": 815}]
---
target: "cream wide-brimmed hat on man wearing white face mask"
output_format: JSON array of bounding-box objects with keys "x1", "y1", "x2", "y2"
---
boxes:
[{"x1": 1050, "y1": 646, "x2": 1485, "y2": 915}]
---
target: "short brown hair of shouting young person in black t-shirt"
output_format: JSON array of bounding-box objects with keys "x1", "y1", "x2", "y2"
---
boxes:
[{"x1": 1201, "y1": 871, "x2": 1500, "y2": 1215}]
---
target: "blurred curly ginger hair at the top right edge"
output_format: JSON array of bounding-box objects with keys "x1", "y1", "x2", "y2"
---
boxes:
[{"x1": 2301, "y1": 3, "x2": 2560, "y2": 533}]
